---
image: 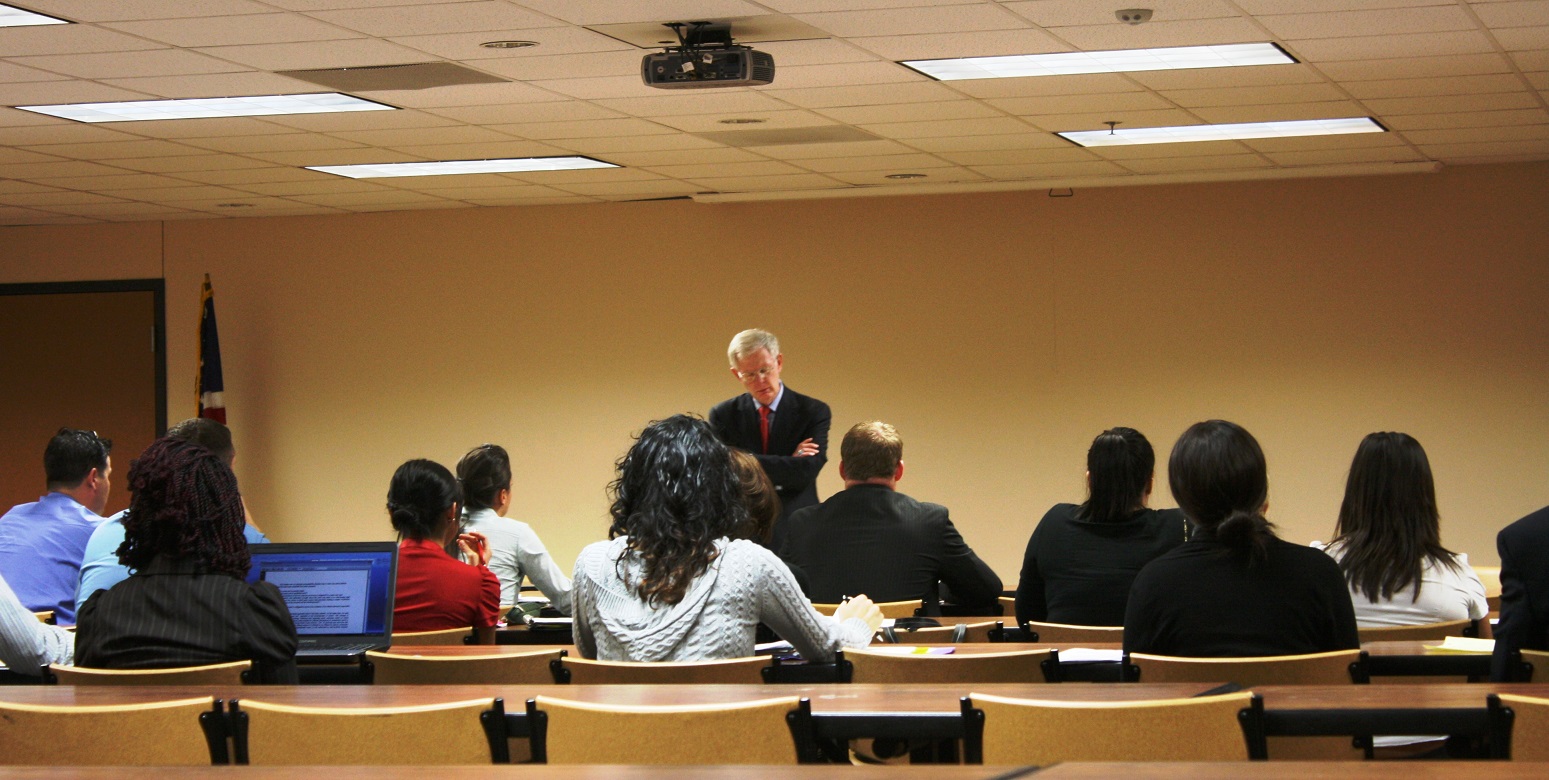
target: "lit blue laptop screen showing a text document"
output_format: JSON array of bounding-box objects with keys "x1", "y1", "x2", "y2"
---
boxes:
[{"x1": 248, "y1": 549, "x2": 393, "y2": 636}]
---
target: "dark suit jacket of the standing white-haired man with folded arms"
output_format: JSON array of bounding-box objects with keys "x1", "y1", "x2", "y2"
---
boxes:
[{"x1": 709, "y1": 385, "x2": 833, "y2": 535}]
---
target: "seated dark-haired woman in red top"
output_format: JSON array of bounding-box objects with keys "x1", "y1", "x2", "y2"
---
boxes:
[{"x1": 387, "y1": 460, "x2": 500, "y2": 644}]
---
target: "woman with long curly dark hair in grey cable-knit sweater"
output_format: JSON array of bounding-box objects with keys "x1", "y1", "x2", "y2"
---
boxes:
[{"x1": 575, "y1": 415, "x2": 881, "y2": 662}]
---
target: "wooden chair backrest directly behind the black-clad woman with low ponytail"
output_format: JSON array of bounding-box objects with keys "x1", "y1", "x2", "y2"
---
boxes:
[{"x1": 1125, "y1": 650, "x2": 1362, "y2": 687}]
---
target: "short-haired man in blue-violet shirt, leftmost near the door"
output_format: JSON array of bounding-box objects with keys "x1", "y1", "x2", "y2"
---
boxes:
[{"x1": 0, "y1": 429, "x2": 113, "y2": 625}]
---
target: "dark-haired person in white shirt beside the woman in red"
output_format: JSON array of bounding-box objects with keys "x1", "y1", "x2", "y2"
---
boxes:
[{"x1": 457, "y1": 444, "x2": 570, "y2": 614}]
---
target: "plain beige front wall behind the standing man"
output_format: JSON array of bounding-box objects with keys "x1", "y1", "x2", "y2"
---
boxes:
[{"x1": 0, "y1": 164, "x2": 1549, "y2": 587}]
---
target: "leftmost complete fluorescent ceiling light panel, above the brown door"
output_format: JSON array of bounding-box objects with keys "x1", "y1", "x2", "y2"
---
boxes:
[{"x1": 17, "y1": 93, "x2": 397, "y2": 122}]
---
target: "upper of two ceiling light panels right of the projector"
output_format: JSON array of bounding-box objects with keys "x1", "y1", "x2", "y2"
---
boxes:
[{"x1": 903, "y1": 43, "x2": 1297, "y2": 80}]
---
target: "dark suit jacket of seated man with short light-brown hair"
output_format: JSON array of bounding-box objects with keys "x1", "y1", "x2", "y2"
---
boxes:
[{"x1": 776, "y1": 484, "x2": 1001, "y2": 614}]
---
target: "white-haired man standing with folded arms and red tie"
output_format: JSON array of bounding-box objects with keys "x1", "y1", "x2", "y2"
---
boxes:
[{"x1": 709, "y1": 328, "x2": 832, "y2": 549}]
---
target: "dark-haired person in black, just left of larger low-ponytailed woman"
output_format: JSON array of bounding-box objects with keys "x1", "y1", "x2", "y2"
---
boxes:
[{"x1": 1016, "y1": 427, "x2": 1188, "y2": 625}]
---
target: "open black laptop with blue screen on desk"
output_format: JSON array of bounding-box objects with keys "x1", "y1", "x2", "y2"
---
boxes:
[{"x1": 248, "y1": 542, "x2": 398, "y2": 661}]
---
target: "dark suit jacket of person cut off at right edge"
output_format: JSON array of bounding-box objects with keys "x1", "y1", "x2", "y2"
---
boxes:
[{"x1": 1490, "y1": 506, "x2": 1549, "y2": 681}]
